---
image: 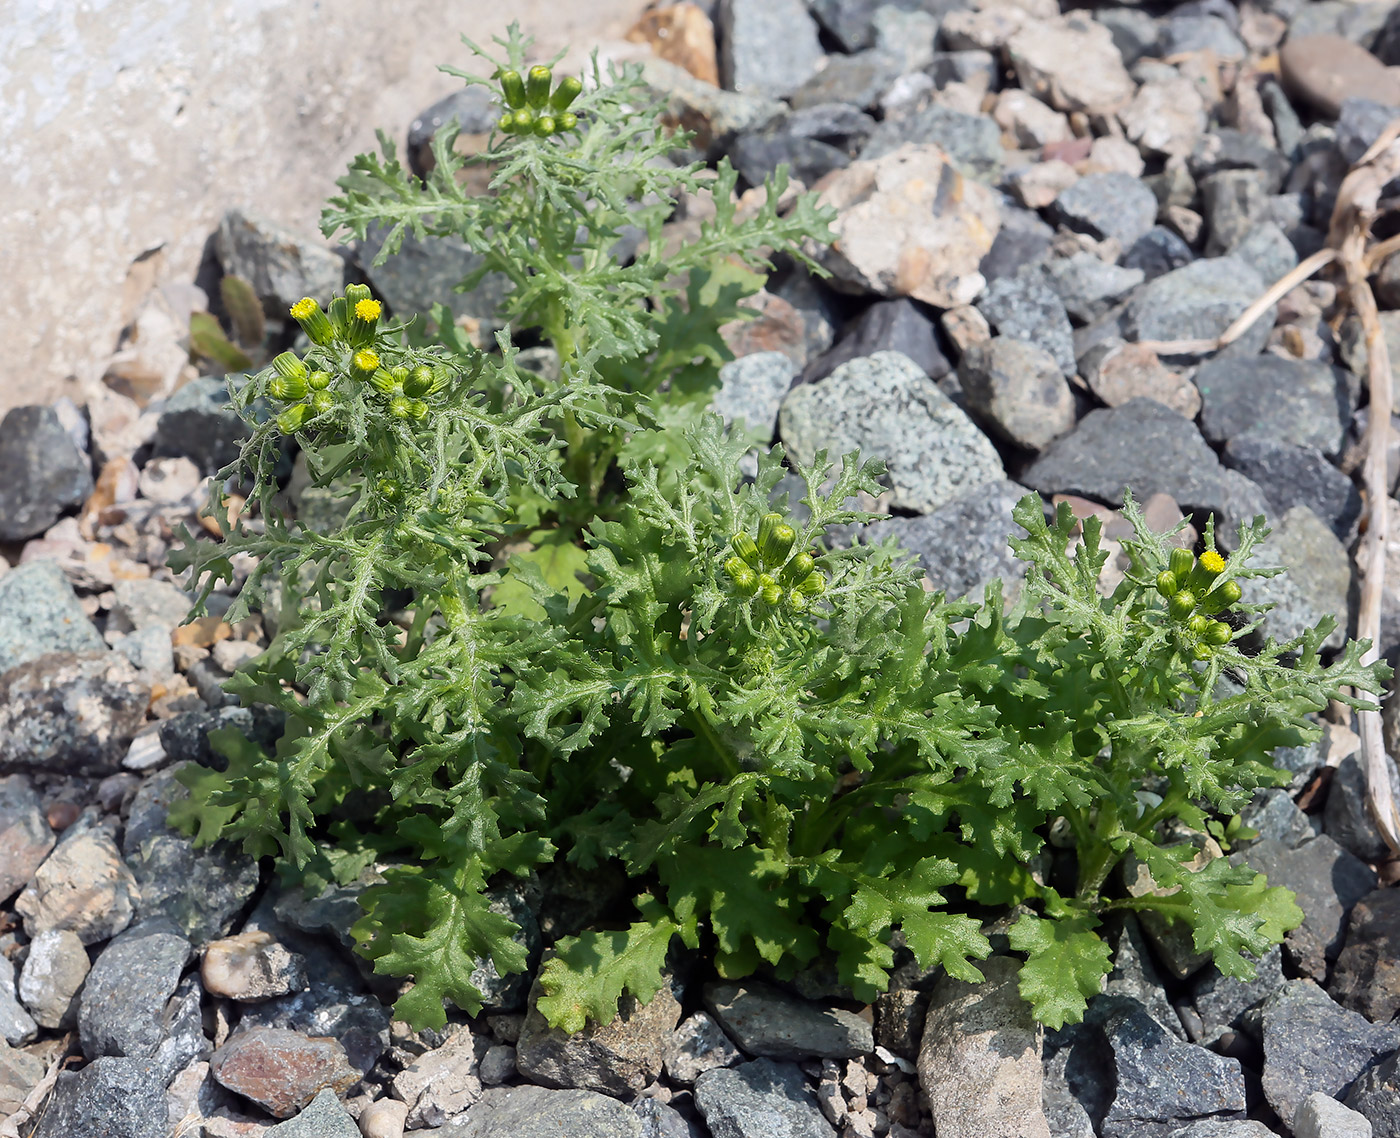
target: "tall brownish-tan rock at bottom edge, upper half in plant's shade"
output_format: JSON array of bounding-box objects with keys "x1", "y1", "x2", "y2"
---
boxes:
[{"x1": 918, "y1": 956, "x2": 1050, "y2": 1138}]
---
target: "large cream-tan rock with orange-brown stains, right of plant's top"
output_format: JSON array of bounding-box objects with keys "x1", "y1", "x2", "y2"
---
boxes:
[{"x1": 818, "y1": 144, "x2": 1001, "y2": 308}]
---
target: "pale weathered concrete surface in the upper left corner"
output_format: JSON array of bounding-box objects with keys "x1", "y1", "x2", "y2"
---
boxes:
[{"x1": 0, "y1": 0, "x2": 643, "y2": 414}]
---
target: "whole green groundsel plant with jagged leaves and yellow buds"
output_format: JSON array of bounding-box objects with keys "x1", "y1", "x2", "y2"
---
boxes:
[{"x1": 172, "y1": 22, "x2": 1386, "y2": 1030}]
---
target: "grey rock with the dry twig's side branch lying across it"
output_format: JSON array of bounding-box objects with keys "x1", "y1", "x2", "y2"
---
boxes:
[{"x1": 1124, "y1": 256, "x2": 1274, "y2": 357}]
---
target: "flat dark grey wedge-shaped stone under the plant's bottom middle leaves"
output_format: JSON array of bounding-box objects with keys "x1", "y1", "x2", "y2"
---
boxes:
[{"x1": 704, "y1": 980, "x2": 875, "y2": 1060}]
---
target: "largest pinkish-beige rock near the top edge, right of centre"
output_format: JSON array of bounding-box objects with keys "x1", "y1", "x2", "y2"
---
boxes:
[{"x1": 1007, "y1": 11, "x2": 1134, "y2": 115}]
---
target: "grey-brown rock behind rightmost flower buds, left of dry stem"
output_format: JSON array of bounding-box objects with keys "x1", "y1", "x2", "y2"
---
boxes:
[{"x1": 1240, "y1": 505, "x2": 1351, "y2": 648}]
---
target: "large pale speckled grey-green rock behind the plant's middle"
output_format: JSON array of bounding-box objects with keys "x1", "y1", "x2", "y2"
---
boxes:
[{"x1": 778, "y1": 351, "x2": 1002, "y2": 514}]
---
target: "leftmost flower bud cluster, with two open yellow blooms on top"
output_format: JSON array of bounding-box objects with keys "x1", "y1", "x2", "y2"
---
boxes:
[{"x1": 280, "y1": 284, "x2": 449, "y2": 434}]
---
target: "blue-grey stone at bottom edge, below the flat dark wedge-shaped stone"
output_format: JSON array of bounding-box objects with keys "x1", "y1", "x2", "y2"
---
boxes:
[{"x1": 694, "y1": 1058, "x2": 836, "y2": 1138}]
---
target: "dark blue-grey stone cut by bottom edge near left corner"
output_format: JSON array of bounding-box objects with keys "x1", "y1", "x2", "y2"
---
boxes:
[{"x1": 31, "y1": 1055, "x2": 169, "y2": 1138}]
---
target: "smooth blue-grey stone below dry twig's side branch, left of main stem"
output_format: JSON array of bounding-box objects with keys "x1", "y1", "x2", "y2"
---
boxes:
[{"x1": 1196, "y1": 356, "x2": 1354, "y2": 458}]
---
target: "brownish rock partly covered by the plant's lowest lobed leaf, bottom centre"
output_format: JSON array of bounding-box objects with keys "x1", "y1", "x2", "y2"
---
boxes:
[{"x1": 515, "y1": 984, "x2": 680, "y2": 1097}]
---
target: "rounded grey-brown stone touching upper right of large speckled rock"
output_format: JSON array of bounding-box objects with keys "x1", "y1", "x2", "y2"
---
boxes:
[{"x1": 958, "y1": 333, "x2": 1074, "y2": 451}]
